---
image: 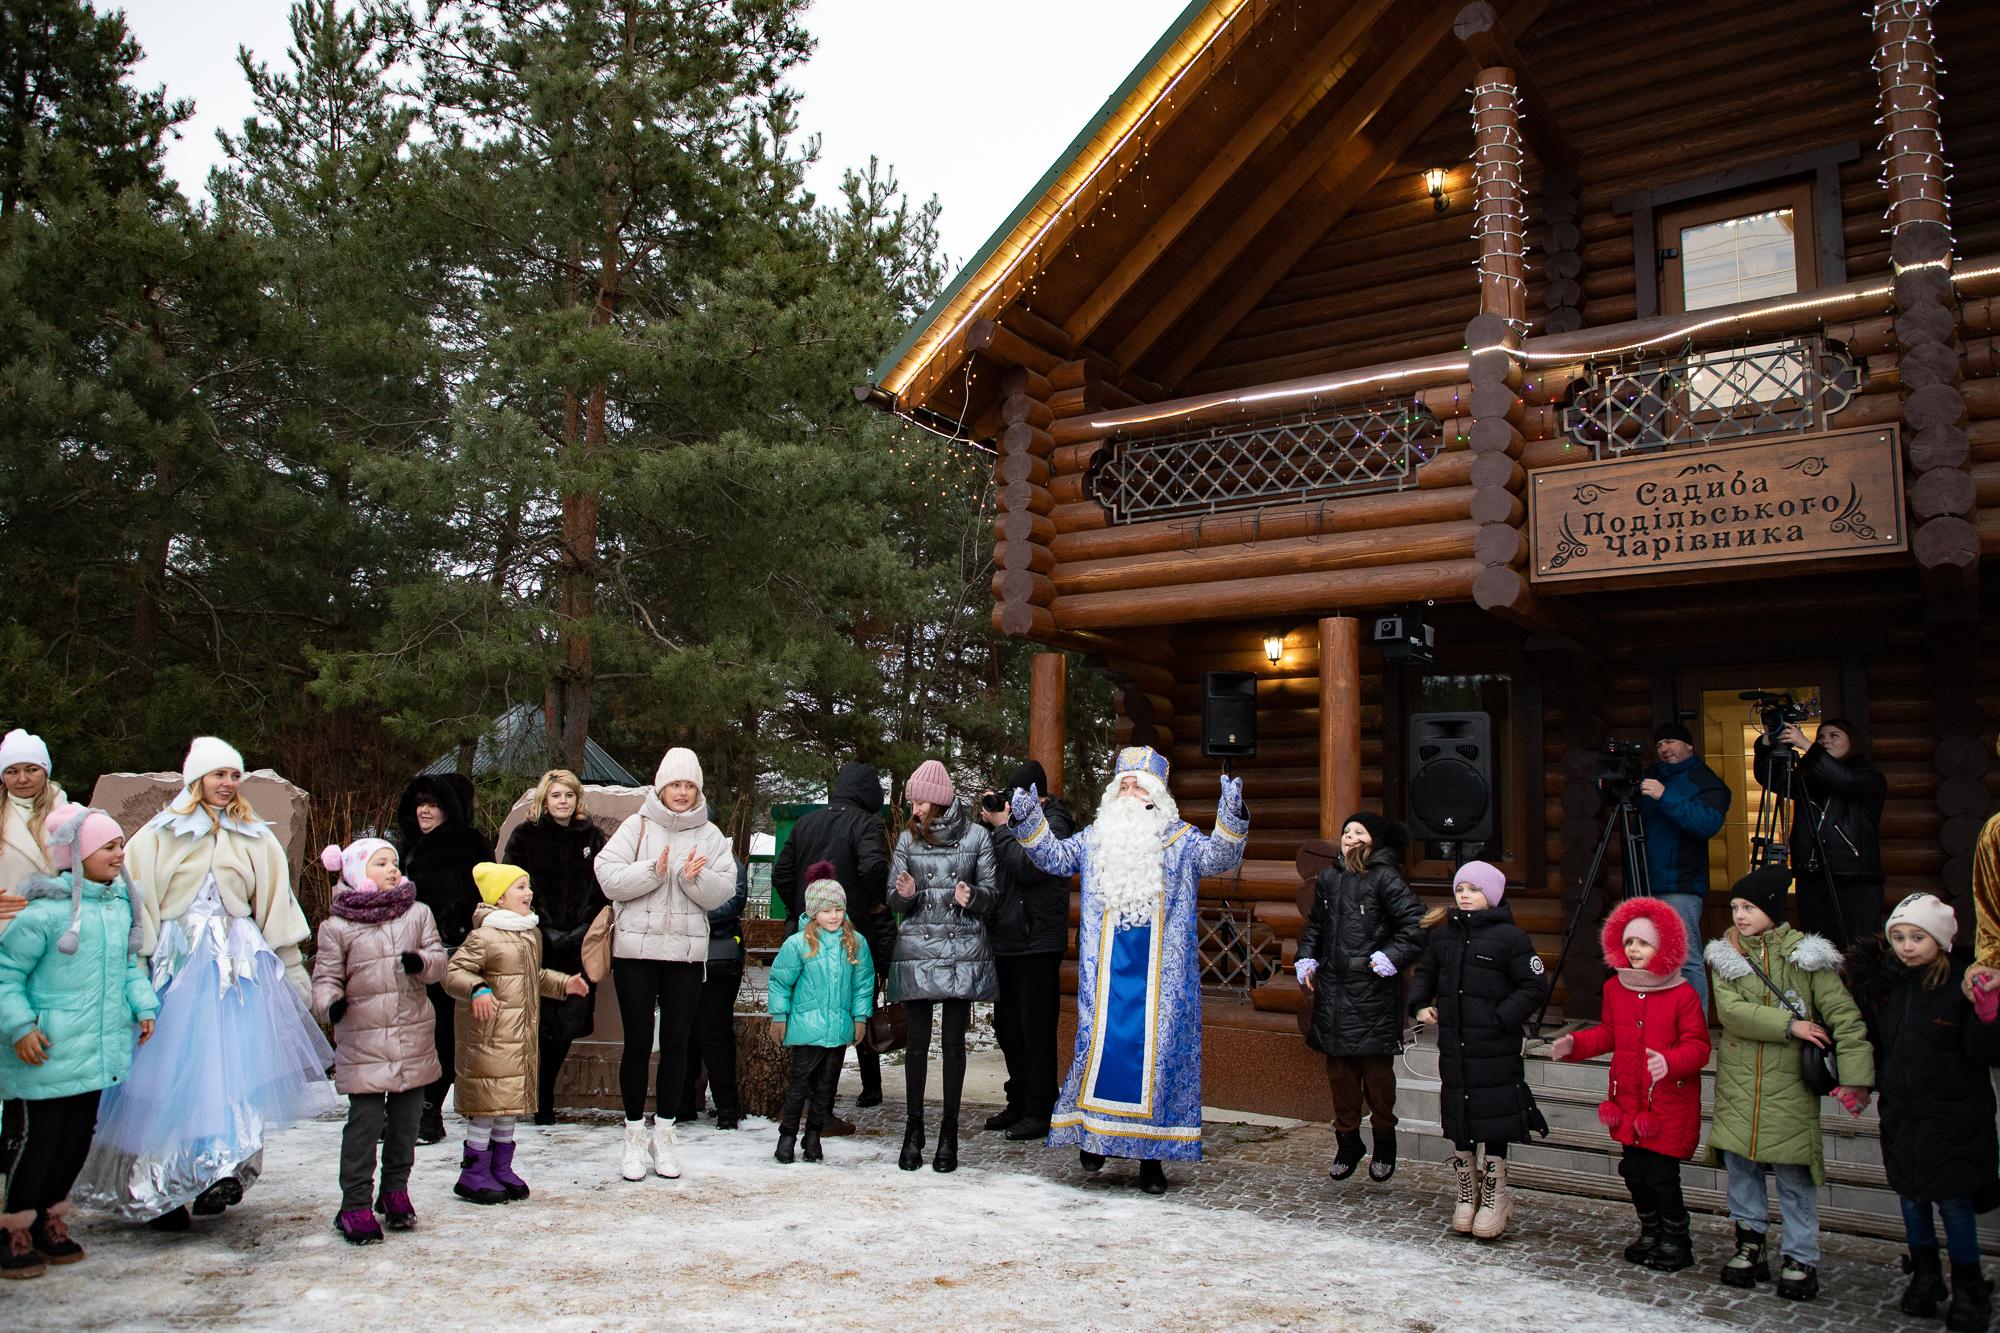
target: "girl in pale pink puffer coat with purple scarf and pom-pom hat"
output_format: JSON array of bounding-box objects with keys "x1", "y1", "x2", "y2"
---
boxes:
[{"x1": 312, "y1": 839, "x2": 450, "y2": 1245}]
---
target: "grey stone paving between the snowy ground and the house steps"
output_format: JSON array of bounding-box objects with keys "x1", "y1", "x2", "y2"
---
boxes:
[{"x1": 820, "y1": 1071, "x2": 1942, "y2": 1331}]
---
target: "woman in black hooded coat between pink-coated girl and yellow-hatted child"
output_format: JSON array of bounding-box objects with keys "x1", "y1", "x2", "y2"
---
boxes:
[{"x1": 396, "y1": 773, "x2": 494, "y2": 1143}]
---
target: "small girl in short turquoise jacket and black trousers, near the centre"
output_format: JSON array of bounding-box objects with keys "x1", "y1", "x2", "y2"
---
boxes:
[{"x1": 770, "y1": 861, "x2": 874, "y2": 1161}]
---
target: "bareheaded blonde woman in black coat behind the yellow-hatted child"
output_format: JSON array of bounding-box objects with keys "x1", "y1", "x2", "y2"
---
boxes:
[{"x1": 500, "y1": 769, "x2": 610, "y2": 1125}]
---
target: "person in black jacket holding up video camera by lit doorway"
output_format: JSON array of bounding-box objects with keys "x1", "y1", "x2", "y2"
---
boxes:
[{"x1": 1756, "y1": 717, "x2": 1888, "y2": 949}]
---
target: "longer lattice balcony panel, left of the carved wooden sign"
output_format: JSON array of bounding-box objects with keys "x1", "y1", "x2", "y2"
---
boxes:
[{"x1": 1088, "y1": 402, "x2": 1442, "y2": 522}]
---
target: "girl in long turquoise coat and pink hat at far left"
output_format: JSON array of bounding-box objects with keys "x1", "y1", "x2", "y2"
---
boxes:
[{"x1": 0, "y1": 805, "x2": 160, "y2": 1277}]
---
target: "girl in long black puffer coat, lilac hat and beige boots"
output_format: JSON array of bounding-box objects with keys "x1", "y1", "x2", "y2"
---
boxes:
[{"x1": 1410, "y1": 861, "x2": 1548, "y2": 1241}]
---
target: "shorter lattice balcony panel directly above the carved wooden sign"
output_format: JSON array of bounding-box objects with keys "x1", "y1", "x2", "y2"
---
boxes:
[{"x1": 1564, "y1": 338, "x2": 1860, "y2": 458}]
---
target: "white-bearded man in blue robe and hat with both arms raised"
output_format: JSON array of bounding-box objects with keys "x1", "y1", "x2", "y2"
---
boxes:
[{"x1": 1012, "y1": 747, "x2": 1250, "y2": 1193}]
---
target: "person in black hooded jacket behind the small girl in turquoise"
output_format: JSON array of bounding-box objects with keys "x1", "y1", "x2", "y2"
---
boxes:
[{"x1": 770, "y1": 763, "x2": 896, "y2": 1107}]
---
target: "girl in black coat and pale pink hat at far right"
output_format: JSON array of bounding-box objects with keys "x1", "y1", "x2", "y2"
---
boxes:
[{"x1": 1842, "y1": 893, "x2": 2000, "y2": 1329}]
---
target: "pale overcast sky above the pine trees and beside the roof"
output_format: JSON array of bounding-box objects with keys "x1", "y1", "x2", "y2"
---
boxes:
[{"x1": 113, "y1": 0, "x2": 1186, "y2": 264}]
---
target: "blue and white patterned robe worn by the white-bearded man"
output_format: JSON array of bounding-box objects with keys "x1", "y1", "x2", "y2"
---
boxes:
[{"x1": 1016, "y1": 799, "x2": 1250, "y2": 1161}]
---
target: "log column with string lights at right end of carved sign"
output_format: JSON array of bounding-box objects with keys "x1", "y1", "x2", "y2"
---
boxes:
[{"x1": 1874, "y1": 0, "x2": 1980, "y2": 616}]
